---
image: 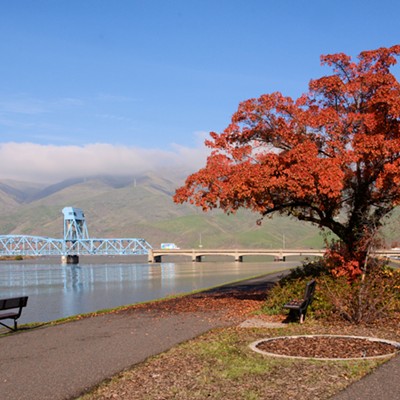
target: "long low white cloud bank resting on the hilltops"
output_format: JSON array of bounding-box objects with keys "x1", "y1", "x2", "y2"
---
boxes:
[{"x1": 0, "y1": 142, "x2": 208, "y2": 183}]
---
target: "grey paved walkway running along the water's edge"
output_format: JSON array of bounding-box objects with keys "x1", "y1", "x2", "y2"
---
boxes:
[{"x1": 0, "y1": 274, "x2": 400, "y2": 400}]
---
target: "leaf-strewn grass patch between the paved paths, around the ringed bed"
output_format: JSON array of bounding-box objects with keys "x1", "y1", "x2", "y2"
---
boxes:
[{"x1": 79, "y1": 327, "x2": 386, "y2": 400}]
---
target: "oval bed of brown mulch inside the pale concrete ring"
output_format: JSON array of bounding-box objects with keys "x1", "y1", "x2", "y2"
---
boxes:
[{"x1": 257, "y1": 336, "x2": 400, "y2": 358}]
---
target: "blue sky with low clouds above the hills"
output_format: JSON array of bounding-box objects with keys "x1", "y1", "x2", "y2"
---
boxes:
[{"x1": 0, "y1": 0, "x2": 400, "y2": 181}]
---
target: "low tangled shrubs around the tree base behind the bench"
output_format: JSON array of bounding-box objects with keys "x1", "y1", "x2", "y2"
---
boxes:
[{"x1": 262, "y1": 260, "x2": 400, "y2": 324}]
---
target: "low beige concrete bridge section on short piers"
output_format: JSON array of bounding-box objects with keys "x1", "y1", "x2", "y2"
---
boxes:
[{"x1": 148, "y1": 249, "x2": 400, "y2": 263}]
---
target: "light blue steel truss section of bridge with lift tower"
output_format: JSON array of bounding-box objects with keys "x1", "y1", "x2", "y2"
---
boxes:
[{"x1": 0, "y1": 207, "x2": 152, "y2": 264}]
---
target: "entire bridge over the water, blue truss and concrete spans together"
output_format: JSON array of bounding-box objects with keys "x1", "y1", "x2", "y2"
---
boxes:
[{"x1": 0, "y1": 207, "x2": 400, "y2": 264}]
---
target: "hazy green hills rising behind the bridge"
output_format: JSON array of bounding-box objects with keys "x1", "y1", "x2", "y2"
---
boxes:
[{"x1": 0, "y1": 173, "x2": 399, "y2": 248}]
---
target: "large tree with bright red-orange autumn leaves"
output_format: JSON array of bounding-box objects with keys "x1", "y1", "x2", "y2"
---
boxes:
[{"x1": 174, "y1": 45, "x2": 400, "y2": 276}]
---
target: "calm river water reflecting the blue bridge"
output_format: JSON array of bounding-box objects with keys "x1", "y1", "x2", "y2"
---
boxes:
[{"x1": 0, "y1": 262, "x2": 295, "y2": 323}]
